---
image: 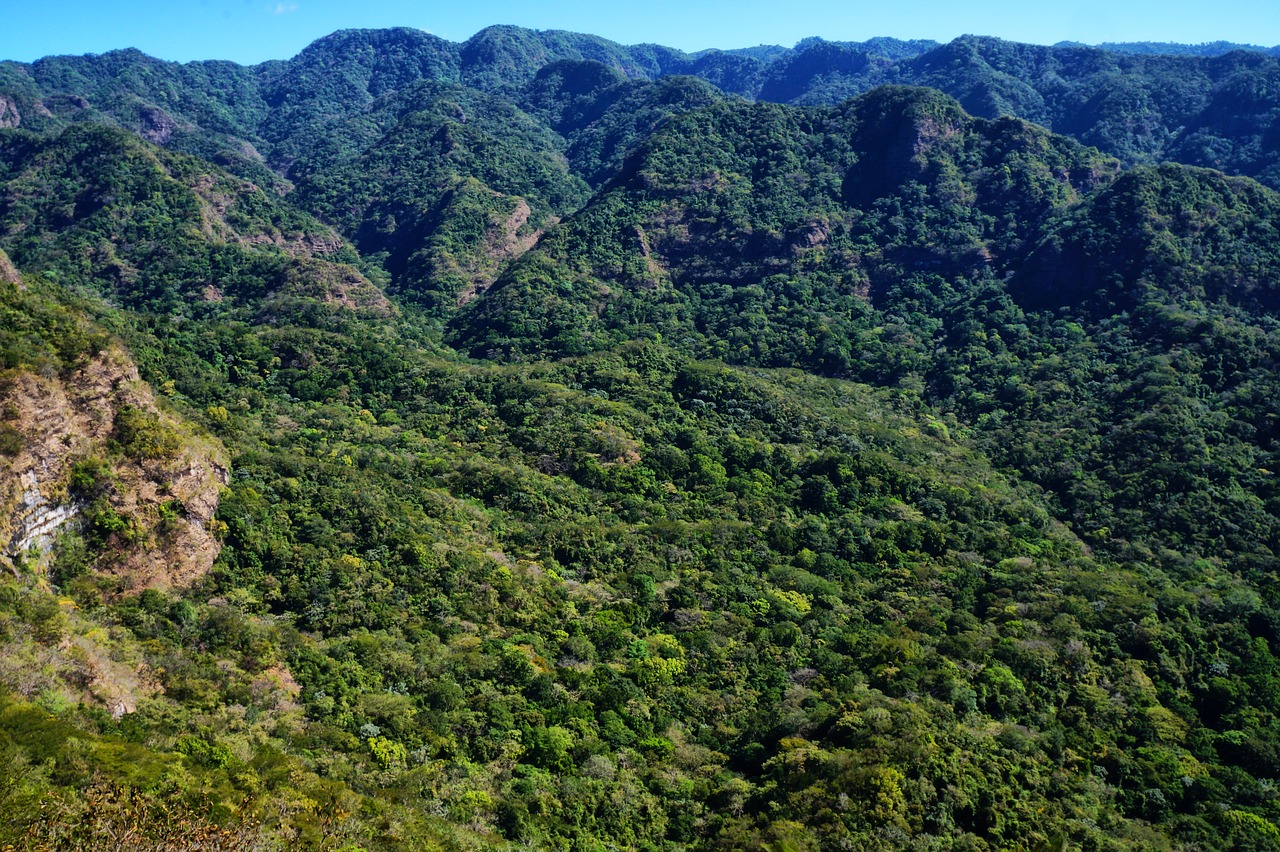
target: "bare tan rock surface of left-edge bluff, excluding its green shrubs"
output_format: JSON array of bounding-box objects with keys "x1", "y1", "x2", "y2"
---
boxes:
[{"x1": 0, "y1": 348, "x2": 228, "y2": 591}]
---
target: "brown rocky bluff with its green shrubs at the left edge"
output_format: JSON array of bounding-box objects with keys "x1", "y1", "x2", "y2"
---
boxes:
[{"x1": 0, "y1": 324, "x2": 228, "y2": 592}]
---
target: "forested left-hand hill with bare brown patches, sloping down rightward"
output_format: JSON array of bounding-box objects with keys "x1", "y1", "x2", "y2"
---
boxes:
[{"x1": 0, "y1": 125, "x2": 387, "y2": 315}]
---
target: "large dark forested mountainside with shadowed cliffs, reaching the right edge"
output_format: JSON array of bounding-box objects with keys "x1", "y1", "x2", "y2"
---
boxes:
[{"x1": 451, "y1": 90, "x2": 1280, "y2": 564}]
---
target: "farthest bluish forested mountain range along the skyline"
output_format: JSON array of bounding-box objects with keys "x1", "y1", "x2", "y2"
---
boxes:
[{"x1": 0, "y1": 27, "x2": 1280, "y2": 187}]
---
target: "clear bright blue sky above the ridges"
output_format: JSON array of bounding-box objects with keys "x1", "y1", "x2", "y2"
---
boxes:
[{"x1": 0, "y1": 0, "x2": 1280, "y2": 64}]
